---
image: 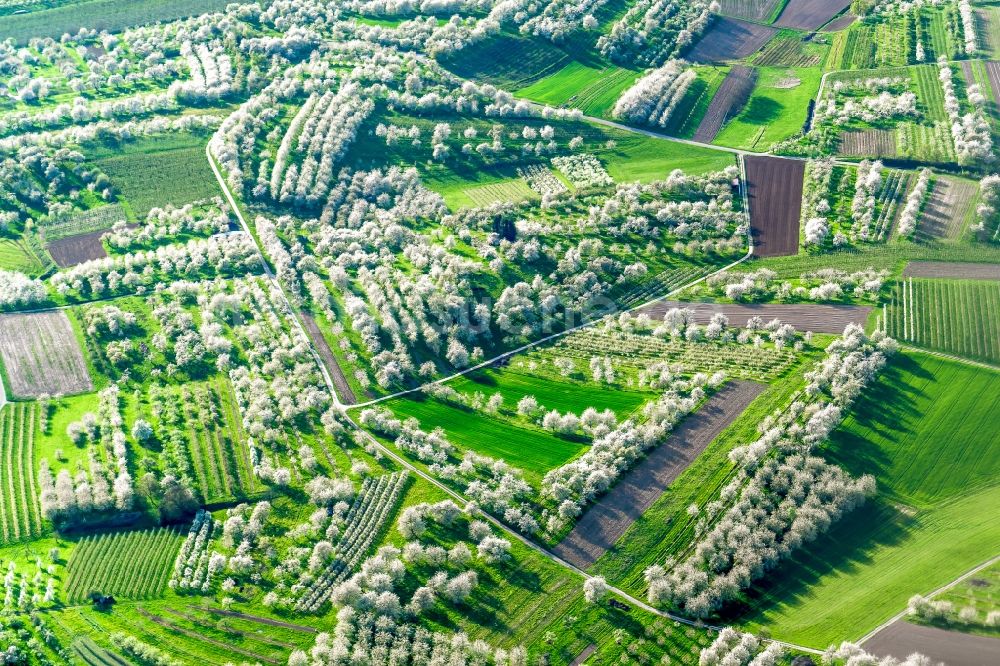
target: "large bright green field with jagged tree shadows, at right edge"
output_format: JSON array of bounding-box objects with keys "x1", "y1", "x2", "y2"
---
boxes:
[{"x1": 740, "y1": 353, "x2": 1000, "y2": 648}]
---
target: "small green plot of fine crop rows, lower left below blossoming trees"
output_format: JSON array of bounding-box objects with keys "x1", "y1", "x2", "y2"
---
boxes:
[{"x1": 66, "y1": 528, "x2": 179, "y2": 603}]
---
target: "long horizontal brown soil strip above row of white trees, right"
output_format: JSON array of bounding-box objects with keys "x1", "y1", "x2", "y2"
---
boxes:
[{"x1": 641, "y1": 301, "x2": 872, "y2": 334}]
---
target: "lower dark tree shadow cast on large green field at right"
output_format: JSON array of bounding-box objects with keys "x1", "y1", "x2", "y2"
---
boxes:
[{"x1": 723, "y1": 498, "x2": 916, "y2": 622}]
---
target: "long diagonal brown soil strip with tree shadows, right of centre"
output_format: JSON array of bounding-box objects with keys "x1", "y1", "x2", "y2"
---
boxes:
[{"x1": 552, "y1": 380, "x2": 764, "y2": 569}]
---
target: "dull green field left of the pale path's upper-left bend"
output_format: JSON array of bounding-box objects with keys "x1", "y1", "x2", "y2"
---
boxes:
[{"x1": 95, "y1": 134, "x2": 220, "y2": 217}]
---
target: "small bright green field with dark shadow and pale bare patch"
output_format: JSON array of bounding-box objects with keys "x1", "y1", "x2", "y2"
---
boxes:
[{"x1": 714, "y1": 67, "x2": 822, "y2": 151}]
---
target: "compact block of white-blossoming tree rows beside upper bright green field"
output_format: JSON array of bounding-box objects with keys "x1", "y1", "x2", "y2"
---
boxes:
[{"x1": 612, "y1": 60, "x2": 698, "y2": 127}]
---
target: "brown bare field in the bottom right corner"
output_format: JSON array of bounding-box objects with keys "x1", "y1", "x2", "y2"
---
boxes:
[{"x1": 862, "y1": 620, "x2": 1000, "y2": 666}]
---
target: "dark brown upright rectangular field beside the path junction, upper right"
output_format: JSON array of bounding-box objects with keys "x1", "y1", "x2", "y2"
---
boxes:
[{"x1": 745, "y1": 155, "x2": 805, "y2": 257}]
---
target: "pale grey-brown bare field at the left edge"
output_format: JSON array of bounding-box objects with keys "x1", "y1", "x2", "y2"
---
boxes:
[{"x1": 0, "y1": 311, "x2": 94, "y2": 398}]
